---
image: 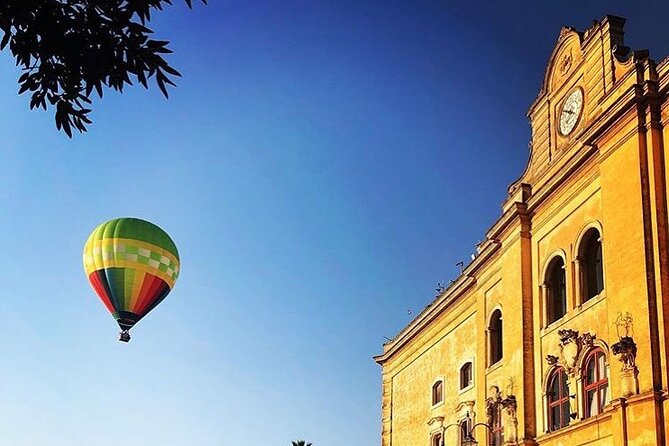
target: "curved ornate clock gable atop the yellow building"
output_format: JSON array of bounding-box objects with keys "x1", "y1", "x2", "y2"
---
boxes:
[{"x1": 523, "y1": 15, "x2": 628, "y2": 188}]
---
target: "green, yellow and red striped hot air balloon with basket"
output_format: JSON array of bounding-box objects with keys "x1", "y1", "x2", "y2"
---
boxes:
[{"x1": 84, "y1": 218, "x2": 179, "y2": 342}]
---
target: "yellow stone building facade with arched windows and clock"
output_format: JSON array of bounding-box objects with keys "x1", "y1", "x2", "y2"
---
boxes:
[{"x1": 375, "y1": 16, "x2": 669, "y2": 446}]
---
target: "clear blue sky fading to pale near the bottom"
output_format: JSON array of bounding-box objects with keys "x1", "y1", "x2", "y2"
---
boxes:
[{"x1": 0, "y1": 0, "x2": 669, "y2": 446}]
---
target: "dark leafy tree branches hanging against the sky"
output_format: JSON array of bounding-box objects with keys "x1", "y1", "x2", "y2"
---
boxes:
[{"x1": 0, "y1": 0, "x2": 206, "y2": 137}]
